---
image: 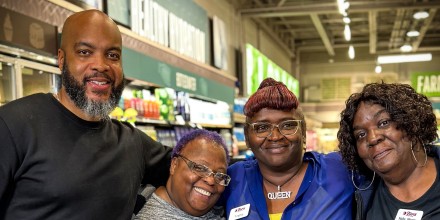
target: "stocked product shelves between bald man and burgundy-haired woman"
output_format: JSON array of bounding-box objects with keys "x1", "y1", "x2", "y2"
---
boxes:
[{"x1": 115, "y1": 85, "x2": 233, "y2": 149}]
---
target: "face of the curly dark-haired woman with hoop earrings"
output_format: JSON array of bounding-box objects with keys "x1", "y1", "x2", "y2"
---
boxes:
[{"x1": 353, "y1": 102, "x2": 415, "y2": 176}]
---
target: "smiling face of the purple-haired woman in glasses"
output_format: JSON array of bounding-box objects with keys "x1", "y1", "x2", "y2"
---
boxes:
[{"x1": 167, "y1": 138, "x2": 227, "y2": 216}]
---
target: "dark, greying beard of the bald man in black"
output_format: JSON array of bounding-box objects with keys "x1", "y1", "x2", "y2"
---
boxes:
[{"x1": 61, "y1": 62, "x2": 125, "y2": 120}]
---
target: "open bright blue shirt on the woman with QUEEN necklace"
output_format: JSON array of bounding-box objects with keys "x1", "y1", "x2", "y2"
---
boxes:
[{"x1": 220, "y1": 152, "x2": 354, "y2": 220}]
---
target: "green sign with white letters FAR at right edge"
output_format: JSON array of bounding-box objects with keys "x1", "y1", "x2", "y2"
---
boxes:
[{"x1": 411, "y1": 72, "x2": 440, "y2": 97}]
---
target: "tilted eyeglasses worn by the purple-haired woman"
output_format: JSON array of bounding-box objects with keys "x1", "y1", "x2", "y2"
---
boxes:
[{"x1": 177, "y1": 154, "x2": 231, "y2": 186}]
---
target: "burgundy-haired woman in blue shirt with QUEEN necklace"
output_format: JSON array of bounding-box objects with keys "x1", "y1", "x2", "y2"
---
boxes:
[{"x1": 220, "y1": 78, "x2": 354, "y2": 220}]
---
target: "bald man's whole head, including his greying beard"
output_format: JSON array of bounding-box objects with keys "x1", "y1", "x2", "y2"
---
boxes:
[{"x1": 58, "y1": 10, "x2": 123, "y2": 118}]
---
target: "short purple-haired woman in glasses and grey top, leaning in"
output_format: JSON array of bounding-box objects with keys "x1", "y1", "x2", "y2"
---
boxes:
[{"x1": 135, "y1": 129, "x2": 231, "y2": 220}]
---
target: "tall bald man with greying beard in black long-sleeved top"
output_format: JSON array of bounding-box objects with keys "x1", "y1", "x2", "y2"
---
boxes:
[{"x1": 0, "y1": 10, "x2": 171, "y2": 220}]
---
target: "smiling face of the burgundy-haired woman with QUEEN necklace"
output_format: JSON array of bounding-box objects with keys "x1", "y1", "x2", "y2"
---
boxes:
[{"x1": 245, "y1": 108, "x2": 304, "y2": 170}]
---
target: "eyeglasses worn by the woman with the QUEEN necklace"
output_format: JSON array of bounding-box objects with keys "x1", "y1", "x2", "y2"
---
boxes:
[{"x1": 247, "y1": 120, "x2": 301, "y2": 138}]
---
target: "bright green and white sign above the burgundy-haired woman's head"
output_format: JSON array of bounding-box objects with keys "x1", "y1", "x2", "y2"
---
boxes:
[{"x1": 246, "y1": 44, "x2": 299, "y2": 97}]
